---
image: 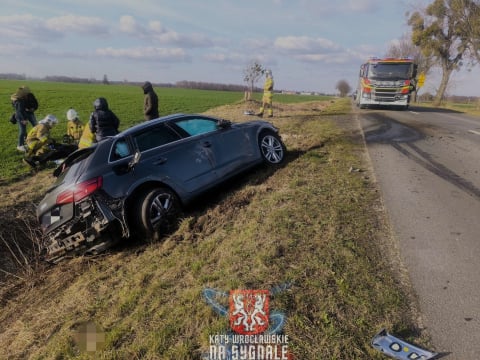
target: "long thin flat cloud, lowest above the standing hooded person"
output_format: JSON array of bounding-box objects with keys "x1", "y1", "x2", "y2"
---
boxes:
[{"x1": 95, "y1": 46, "x2": 190, "y2": 62}]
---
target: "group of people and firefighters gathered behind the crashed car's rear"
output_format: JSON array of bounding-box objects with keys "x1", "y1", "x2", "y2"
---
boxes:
[{"x1": 10, "y1": 81, "x2": 159, "y2": 170}]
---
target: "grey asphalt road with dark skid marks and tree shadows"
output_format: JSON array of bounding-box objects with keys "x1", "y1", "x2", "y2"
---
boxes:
[{"x1": 356, "y1": 107, "x2": 480, "y2": 360}]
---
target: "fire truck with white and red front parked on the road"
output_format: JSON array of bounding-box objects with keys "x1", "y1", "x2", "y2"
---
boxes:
[{"x1": 355, "y1": 58, "x2": 417, "y2": 109}]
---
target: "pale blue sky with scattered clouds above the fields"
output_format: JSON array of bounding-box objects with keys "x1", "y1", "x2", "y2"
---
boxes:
[{"x1": 0, "y1": 0, "x2": 480, "y2": 96}]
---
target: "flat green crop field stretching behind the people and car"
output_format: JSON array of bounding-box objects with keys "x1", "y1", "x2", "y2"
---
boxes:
[{"x1": 0, "y1": 80, "x2": 330, "y2": 183}]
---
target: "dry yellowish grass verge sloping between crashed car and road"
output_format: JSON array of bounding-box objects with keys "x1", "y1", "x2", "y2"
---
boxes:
[{"x1": 0, "y1": 100, "x2": 424, "y2": 359}]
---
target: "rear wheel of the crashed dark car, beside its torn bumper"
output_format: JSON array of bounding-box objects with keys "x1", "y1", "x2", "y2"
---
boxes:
[{"x1": 132, "y1": 188, "x2": 180, "y2": 241}]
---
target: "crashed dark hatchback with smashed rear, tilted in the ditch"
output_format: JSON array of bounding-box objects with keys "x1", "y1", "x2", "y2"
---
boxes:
[{"x1": 37, "y1": 114, "x2": 286, "y2": 262}]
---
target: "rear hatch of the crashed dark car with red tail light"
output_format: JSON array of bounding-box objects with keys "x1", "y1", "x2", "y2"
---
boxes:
[{"x1": 37, "y1": 148, "x2": 101, "y2": 234}]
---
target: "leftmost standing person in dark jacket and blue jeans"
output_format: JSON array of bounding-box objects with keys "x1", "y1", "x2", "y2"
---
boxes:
[{"x1": 10, "y1": 86, "x2": 38, "y2": 152}]
